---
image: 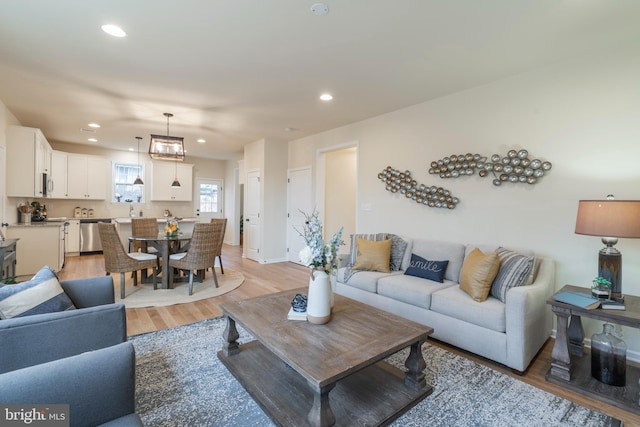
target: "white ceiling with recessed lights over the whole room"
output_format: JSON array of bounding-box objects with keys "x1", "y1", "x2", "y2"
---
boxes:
[{"x1": 0, "y1": 0, "x2": 640, "y2": 159}]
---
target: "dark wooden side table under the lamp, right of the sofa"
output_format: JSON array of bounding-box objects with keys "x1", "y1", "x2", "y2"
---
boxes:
[{"x1": 546, "y1": 285, "x2": 640, "y2": 414}]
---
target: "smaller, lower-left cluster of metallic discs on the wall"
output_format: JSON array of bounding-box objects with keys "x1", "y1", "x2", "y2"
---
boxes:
[{"x1": 378, "y1": 166, "x2": 460, "y2": 209}]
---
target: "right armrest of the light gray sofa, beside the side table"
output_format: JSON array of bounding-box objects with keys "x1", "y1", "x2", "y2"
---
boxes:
[{"x1": 506, "y1": 258, "x2": 555, "y2": 371}]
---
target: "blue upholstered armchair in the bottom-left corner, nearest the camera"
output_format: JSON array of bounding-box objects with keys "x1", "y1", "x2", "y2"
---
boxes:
[{"x1": 0, "y1": 342, "x2": 142, "y2": 426}]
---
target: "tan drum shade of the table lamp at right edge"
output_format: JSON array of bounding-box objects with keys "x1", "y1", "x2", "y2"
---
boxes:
[{"x1": 575, "y1": 200, "x2": 640, "y2": 238}]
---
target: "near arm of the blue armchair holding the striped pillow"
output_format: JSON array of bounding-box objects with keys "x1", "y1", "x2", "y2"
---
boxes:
[{"x1": 0, "y1": 304, "x2": 127, "y2": 373}]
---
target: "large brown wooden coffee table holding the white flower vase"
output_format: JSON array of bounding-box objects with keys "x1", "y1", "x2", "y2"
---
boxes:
[{"x1": 218, "y1": 288, "x2": 433, "y2": 426}]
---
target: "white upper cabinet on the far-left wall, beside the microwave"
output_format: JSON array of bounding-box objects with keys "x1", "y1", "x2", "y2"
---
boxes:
[{"x1": 6, "y1": 126, "x2": 53, "y2": 197}]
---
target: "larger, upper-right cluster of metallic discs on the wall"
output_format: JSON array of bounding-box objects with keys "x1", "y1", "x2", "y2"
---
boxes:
[{"x1": 429, "y1": 150, "x2": 551, "y2": 186}]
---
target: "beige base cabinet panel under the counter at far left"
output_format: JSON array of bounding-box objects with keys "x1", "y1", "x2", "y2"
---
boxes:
[{"x1": 7, "y1": 223, "x2": 64, "y2": 276}]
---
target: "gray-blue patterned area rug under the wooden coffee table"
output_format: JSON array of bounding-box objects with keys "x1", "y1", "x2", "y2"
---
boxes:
[{"x1": 129, "y1": 318, "x2": 619, "y2": 427}]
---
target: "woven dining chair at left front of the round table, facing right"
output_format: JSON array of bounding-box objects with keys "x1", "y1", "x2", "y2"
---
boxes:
[{"x1": 98, "y1": 222, "x2": 158, "y2": 299}]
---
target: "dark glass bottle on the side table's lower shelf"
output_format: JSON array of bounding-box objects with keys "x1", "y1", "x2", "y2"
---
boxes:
[{"x1": 591, "y1": 323, "x2": 627, "y2": 386}]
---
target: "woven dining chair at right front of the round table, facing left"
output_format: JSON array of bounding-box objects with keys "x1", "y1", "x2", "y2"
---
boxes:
[{"x1": 169, "y1": 222, "x2": 224, "y2": 295}]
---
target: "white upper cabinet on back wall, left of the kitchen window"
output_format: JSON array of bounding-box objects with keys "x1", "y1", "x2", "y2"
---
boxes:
[{"x1": 67, "y1": 153, "x2": 111, "y2": 200}]
